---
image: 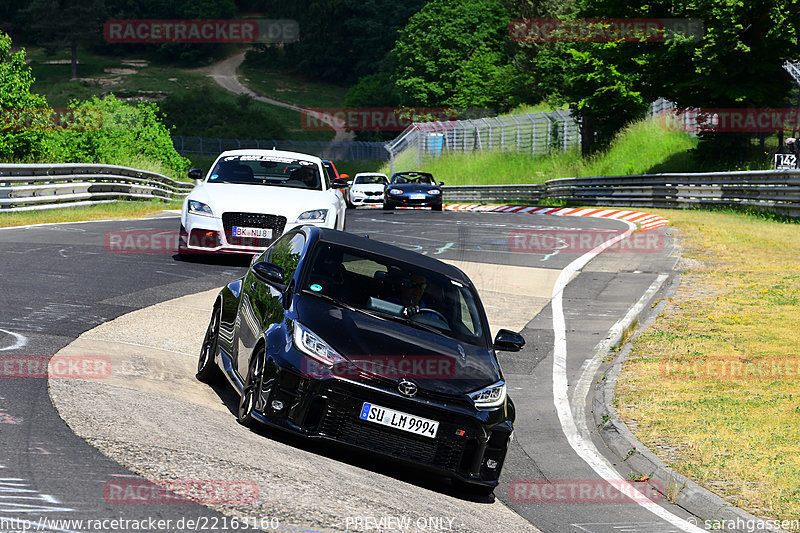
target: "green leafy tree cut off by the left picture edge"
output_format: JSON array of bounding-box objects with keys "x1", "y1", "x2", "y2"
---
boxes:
[{"x1": 0, "y1": 32, "x2": 47, "y2": 160}]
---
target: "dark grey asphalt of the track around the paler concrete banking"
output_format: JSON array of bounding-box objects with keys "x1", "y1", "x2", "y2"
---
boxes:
[{"x1": 0, "y1": 210, "x2": 688, "y2": 533}]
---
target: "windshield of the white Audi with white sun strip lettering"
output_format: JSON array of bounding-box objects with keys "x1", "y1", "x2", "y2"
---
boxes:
[{"x1": 208, "y1": 155, "x2": 322, "y2": 191}]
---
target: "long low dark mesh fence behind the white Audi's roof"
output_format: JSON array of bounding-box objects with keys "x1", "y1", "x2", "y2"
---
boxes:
[{"x1": 172, "y1": 135, "x2": 389, "y2": 161}]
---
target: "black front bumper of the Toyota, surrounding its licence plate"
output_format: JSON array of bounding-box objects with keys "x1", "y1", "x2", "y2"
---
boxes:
[{"x1": 256, "y1": 370, "x2": 514, "y2": 486}]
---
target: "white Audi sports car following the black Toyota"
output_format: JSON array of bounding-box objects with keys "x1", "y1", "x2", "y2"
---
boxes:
[{"x1": 178, "y1": 149, "x2": 347, "y2": 254}]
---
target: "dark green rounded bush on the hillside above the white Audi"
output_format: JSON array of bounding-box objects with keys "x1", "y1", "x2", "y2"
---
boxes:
[{"x1": 160, "y1": 87, "x2": 286, "y2": 139}]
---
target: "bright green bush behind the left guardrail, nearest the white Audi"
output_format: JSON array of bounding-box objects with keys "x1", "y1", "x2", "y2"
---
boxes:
[{"x1": 42, "y1": 95, "x2": 189, "y2": 178}]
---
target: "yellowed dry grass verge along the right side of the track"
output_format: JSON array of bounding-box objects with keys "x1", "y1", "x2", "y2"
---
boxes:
[{"x1": 616, "y1": 211, "x2": 800, "y2": 519}]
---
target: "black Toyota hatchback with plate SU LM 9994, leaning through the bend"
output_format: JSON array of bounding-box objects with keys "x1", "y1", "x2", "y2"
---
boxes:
[{"x1": 197, "y1": 226, "x2": 525, "y2": 493}]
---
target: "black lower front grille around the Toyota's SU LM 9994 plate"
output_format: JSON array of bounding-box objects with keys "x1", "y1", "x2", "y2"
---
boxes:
[{"x1": 320, "y1": 393, "x2": 465, "y2": 472}]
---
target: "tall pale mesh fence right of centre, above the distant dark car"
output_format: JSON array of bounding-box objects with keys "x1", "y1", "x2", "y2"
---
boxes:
[{"x1": 386, "y1": 111, "x2": 581, "y2": 172}]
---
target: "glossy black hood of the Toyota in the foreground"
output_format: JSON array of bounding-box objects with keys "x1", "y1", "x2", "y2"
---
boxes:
[{"x1": 295, "y1": 293, "x2": 501, "y2": 395}]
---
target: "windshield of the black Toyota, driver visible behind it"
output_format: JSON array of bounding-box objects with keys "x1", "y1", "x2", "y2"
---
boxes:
[{"x1": 302, "y1": 243, "x2": 486, "y2": 345}]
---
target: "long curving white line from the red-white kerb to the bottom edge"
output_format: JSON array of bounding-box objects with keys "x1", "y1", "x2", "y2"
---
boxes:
[{"x1": 551, "y1": 221, "x2": 705, "y2": 533}]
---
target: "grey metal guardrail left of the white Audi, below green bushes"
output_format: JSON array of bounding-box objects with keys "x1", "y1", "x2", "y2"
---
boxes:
[{"x1": 0, "y1": 163, "x2": 194, "y2": 212}]
